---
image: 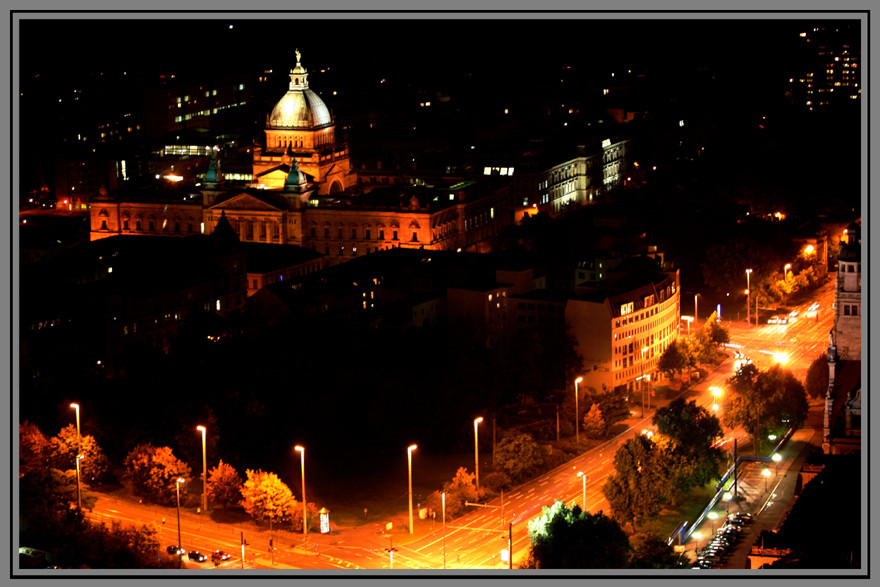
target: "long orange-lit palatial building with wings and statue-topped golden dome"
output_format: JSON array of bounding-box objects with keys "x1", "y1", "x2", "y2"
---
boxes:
[{"x1": 90, "y1": 52, "x2": 513, "y2": 265}]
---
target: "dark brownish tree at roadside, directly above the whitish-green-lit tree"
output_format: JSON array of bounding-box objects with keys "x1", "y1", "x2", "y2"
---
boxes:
[{"x1": 602, "y1": 434, "x2": 674, "y2": 529}]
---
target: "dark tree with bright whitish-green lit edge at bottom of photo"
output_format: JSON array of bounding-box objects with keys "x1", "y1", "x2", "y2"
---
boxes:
[{"x1": 526, "y1": 501, "x2": 631, "y2": 569}]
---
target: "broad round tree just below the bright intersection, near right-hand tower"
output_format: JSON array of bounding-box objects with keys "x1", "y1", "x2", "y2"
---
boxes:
[{"x1": 724, "y1": 364, "x2": 809, "y2": 448}]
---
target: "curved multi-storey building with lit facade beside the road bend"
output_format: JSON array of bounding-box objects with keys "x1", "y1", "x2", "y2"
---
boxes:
[{"x1": 565, "y1": 270, "x2": 681, "y2": 392}]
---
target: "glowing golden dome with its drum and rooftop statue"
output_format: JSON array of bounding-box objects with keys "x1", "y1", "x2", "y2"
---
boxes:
[{"x1": 254, "y1": 50, "x2": 357, "y2": 195}]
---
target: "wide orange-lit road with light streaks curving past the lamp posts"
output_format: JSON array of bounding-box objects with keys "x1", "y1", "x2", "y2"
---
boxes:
[{"x1": 91, "y1": 281, "x2": 834, "y2": 569}]
